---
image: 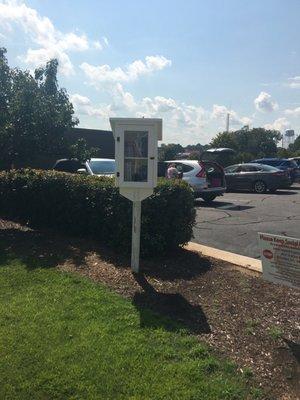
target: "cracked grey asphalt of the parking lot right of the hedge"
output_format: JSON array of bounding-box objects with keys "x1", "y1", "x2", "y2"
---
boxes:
[{"x1": 192, "y1": 184, "x2": 300, "y2": 258}]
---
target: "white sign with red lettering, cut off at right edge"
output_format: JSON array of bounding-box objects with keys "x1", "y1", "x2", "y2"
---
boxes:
[{"x1": 258, "y1": 233, "x2": 300, "y2": 289}]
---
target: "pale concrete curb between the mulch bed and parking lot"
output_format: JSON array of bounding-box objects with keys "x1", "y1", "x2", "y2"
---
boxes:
[{"x1": 185, "y1": 242, "x2": 262, "y2": 273}]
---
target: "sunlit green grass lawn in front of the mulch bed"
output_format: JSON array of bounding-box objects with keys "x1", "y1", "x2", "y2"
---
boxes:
[{"x1": 0, "y1": 252, "x2": 252, "y2": 400}]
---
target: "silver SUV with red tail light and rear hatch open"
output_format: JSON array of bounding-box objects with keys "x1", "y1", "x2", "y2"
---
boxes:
[{"x1": 163, "y1": 160, "x2": 226, "y2": 202}]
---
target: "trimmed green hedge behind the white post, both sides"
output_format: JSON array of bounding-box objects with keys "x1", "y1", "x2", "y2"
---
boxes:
[{"x1": 0, "y1": 169, "x2": 195, "y2": 254}]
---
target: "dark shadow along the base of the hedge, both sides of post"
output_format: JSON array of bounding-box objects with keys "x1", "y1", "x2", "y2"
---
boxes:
[{"x1": 0, "y1": 228, "x2": 211, "y2": 281}]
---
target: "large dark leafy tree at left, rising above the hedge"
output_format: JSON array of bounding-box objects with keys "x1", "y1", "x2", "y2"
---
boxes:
[{"x1": 0, "y1": 49, "x2": 78, "y2": 167}]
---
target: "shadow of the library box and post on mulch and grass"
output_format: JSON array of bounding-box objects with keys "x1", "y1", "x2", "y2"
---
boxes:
[{"x1": 132, "y1": 274, "x2": 211, "y2": 334}]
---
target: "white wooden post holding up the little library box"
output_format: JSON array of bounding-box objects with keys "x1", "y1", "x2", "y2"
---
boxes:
[{"x1": 131, "y1": 201, "x2": 142, "y2": 273}]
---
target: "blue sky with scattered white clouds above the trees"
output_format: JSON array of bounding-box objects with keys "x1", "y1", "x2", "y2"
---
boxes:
[{"x1": 0, "y1": 0, "x2": 300, "y2": 144}]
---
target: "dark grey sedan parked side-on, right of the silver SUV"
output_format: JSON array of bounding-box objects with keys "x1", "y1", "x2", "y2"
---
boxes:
[{"x1": 225, "y1": 163, "x2": 291, "y2": 193}]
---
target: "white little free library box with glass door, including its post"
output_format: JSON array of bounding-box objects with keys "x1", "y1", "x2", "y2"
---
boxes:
[{"x1": 109, "y1": 118, "x2": 162, "y2": 272}]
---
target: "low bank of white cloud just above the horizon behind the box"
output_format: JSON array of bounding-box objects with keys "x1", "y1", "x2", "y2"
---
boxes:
[{"x1": 71, "y1": 87, "x2": 284, "y2": 145}]
